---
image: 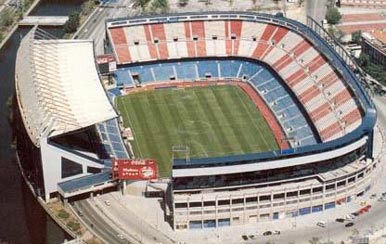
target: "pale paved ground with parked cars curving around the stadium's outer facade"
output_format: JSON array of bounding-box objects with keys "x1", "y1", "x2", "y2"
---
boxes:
[{"x1": 87, "y1": 113, "x2": 386, "y2": 243}]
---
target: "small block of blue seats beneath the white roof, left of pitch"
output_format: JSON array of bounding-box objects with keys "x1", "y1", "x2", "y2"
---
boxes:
[{"x1": 97, "y1": 119, "x2": 129, "y2": 158}]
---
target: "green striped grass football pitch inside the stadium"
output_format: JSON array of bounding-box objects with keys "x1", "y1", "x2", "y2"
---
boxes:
[{"x1": 117, "y1": 86, "x2": 278, "y2": 176}]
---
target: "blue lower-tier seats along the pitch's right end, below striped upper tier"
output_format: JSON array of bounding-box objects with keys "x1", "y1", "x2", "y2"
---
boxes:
[{"x1": 247, "y1": 68, "x2": 317, "y2": 147}]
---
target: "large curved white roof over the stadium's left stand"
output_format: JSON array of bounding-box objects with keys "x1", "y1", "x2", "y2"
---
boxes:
[{"x1": 15, "y1": 28, "x2": 117, "y2": 146}]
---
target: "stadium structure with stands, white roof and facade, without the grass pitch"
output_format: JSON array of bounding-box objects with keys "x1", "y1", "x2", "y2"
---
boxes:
[{"x1": 16, "y1": 12, "x2": 377, "y2": 230}]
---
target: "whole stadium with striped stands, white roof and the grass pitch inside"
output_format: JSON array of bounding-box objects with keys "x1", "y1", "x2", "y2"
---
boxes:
[{"x1": 16, "y1": 12, "x2": 377, "y2": 230}]
